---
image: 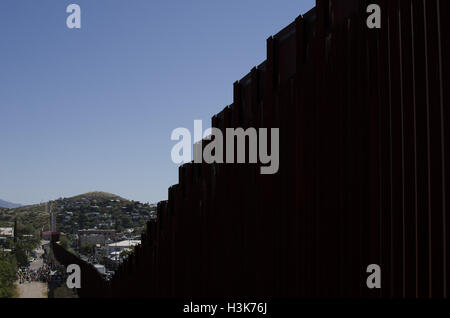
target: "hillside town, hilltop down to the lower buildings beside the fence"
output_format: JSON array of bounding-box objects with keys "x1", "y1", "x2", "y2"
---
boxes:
[{"x1": 0, "y1": 192, "x2": 156, "y2": 279}]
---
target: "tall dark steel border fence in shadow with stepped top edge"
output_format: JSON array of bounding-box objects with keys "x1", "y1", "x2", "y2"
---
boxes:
[{"x1": 67, "y1": 0, "x2": 450, "y2": 298}]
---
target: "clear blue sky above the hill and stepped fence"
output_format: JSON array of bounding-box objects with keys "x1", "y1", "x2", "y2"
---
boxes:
[{"x1": 0, "y1": 0, "x2": 314, "y2": 204}]
